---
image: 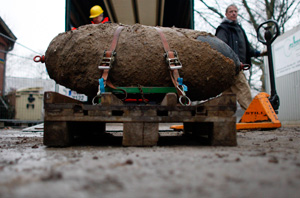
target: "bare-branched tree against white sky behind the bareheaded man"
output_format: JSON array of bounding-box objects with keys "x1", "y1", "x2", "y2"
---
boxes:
[{"x1": 195, "y1": 0, "x2": 300, "y2": 91}]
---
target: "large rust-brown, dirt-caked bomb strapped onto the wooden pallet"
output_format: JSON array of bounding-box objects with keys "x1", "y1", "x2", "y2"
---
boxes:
[{"x1": 45, "y1": 23, "x2": 240, "y2": 100}]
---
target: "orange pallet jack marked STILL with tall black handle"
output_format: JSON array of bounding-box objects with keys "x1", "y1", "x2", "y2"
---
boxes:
[{"x1": 170, "y1": 20, "x2": 281, "y2": 130}]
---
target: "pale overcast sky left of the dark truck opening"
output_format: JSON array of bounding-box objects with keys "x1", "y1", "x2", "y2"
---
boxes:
[{"x1": 0, "y1": 0, "x2": 65, "y2": 55}]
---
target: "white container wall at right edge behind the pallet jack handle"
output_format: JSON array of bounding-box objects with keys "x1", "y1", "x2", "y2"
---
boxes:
[{"x1": 265, "y1": 25, "x2": 300, "y2": 124}]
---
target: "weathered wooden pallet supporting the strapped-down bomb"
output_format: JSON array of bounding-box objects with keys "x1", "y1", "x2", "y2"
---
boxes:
[{"x1": 44, "y1": 92, "x2": 237, "y2": 147}]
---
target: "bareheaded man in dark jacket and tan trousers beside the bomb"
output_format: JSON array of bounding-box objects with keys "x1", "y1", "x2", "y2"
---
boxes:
[{"x1": 216, "y1": 4, "x2": 260, "y2": 110}]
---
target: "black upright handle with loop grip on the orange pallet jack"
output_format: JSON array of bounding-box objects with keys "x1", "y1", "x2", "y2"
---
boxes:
[{"x1": 256, "y1": 20, "x2": 280, "y2": 114}]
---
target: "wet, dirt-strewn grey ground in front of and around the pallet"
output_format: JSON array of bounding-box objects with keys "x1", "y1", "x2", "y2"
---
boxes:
[{"x1": 0, "y1": 127, "x2": 300, "y2": 198}]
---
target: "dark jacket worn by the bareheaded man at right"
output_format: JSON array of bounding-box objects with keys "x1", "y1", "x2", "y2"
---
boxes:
[{"x1": 215, "y1": 20, "x2": 260, "y2": 65}]
